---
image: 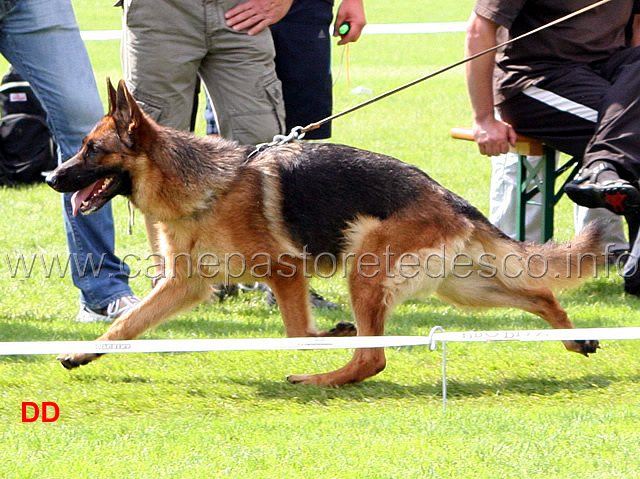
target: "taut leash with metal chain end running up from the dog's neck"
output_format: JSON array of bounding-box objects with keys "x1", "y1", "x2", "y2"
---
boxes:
[{"x1": 247, "y1": 0, "x2": 612, "y2": 159}]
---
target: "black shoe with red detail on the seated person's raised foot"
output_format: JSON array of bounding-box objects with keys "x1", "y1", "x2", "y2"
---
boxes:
[{"x1": 564, "y1": 162, "x2": 640, "y2": 215}]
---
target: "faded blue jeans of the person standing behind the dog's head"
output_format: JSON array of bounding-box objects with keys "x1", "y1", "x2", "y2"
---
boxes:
[{"x1": 0, "y1": 0, "x2": 133, "y2": 309}]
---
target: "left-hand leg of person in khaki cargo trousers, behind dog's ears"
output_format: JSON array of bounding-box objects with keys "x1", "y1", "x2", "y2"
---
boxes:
[{"x1": 121, "y1": 0, "x2": 207, "y2": 270}]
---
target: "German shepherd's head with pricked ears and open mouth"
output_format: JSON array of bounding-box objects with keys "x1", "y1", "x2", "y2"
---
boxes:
[{"x1": 46, "y1": 78, "x2": 149, "y2": 216}]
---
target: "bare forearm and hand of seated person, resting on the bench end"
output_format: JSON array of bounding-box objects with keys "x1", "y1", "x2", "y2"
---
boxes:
[{"x1": 465, "y1": 12, "x2": 517, "y2": 156}]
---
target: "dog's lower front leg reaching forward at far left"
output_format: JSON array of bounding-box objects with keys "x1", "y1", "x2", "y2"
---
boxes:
[{"x1": 58, "y1": 278, "x2": 209, "y2": 369}]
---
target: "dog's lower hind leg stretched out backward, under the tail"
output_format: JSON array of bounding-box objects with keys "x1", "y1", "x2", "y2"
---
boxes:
[{"x1": 437, "y1": 278, "x2": 598, "y2": 356}]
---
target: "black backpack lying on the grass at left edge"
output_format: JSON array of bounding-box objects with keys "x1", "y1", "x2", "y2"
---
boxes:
[{"x1": 0, "y1": 68, "x2": 57, "y2": 186}]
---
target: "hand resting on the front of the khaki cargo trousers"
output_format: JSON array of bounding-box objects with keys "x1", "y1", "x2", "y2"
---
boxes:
[{"x1": 224, "y1": 0, "x2": 293, "y2": 35}]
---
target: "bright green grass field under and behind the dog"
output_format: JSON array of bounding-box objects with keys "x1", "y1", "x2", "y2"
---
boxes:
[{"x1": 0, "y1": 0, "x2": 640, "y2": 479}]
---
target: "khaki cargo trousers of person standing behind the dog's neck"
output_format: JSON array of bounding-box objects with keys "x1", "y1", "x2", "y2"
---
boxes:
[{"x1": 122, "y1": 0, "x2": 285, "y2": 144}]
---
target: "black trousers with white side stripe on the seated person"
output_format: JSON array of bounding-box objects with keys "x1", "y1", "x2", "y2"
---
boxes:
[{"x1": 498, "y1": 47, "x2": 640, "y2": 182}]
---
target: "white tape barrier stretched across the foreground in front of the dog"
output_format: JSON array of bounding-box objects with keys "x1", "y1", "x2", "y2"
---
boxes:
[{"x1": 0, "y1": 327, "x2": 640, "y2": 356}]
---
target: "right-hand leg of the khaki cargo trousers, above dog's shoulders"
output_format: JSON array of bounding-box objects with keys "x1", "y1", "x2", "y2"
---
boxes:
[{"x1": 200, "y1": 0, "x2": 285, "y2": 145}]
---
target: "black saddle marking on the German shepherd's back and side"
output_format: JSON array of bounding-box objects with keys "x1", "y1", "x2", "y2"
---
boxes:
[{"x1": 280, "y1": 144, "x2": 437, "y2": 256}]
